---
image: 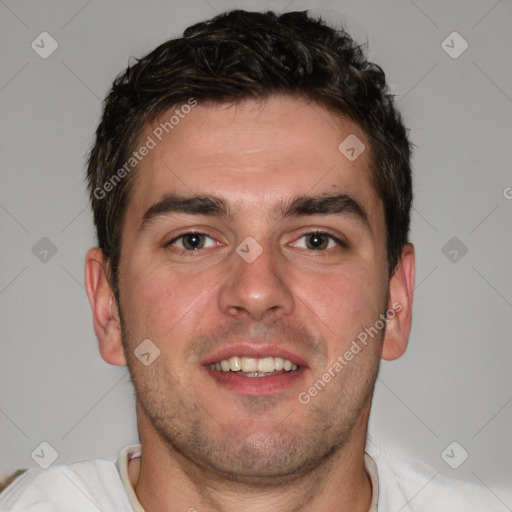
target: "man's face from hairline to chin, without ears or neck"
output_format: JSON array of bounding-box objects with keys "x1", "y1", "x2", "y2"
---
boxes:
[{"x1": 115, "y1": 97, "x2": 388, "y2": 479}]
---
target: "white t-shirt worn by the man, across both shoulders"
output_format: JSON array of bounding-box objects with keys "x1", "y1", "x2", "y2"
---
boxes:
[{"x1": 0, "y1": 445, "x2": 510, "y2": 512}]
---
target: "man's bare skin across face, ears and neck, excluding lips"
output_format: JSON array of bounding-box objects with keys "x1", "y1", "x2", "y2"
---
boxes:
[{"x1": 86, "y1": 96, "x2": 414, "y2": 512}]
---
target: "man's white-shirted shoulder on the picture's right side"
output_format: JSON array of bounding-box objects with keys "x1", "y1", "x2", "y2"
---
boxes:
[{"x1": 368, "y1": 446, "x2": 510, "y2": 512}]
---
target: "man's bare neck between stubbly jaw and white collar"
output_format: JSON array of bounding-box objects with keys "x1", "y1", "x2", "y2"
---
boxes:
[{"x1": 129, "y1": 404, "x2": 372, "y2": 512}]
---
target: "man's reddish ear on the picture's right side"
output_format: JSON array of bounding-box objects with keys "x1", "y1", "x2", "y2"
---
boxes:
[{"x1": 382, "y1": 244, "x2": 415, "y2": 361}]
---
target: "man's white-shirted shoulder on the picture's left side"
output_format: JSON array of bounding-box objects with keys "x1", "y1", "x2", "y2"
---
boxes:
[{"x1": 0, "y1": 459, "x2": 132, "y2": 512}]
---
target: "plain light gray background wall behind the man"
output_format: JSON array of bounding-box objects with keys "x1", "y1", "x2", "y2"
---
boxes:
[{"x1": 0, "y1": 0, "x2": 512, "y2": 504}]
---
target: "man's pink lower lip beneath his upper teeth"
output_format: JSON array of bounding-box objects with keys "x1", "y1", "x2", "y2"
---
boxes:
[{"x1": 205, "y1": 367, "x2": 305, "y2": 395}]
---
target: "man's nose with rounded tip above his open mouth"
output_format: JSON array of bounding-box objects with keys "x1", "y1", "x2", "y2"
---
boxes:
[{"x1": 218, "y1": 239, "x2": 294, "y2": 321}]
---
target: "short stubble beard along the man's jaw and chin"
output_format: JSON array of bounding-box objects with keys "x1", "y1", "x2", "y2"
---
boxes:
[{"x1": 121, "y1": 322, "x2": 381, "y2": 488}]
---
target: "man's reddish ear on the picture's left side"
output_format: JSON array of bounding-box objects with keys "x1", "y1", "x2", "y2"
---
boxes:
[{"x1": 85, "y1": 247, "x2": 126, "y2": 366}]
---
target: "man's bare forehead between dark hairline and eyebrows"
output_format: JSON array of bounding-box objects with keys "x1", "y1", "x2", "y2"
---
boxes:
[{"x1": 123, "y1": 96, "x2": 382, "y2": 229}]
